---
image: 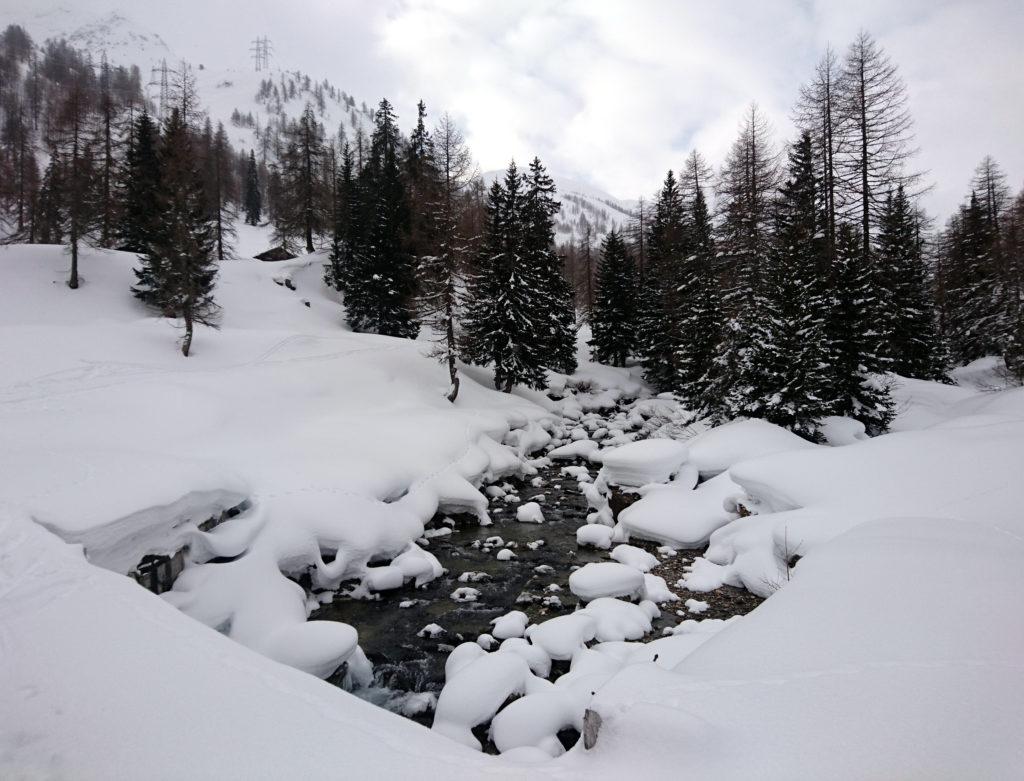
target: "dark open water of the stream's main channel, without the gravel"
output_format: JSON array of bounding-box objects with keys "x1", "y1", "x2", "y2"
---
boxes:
[{"x1": 310, "y1": 463, "x2": 607, "y2": 712}]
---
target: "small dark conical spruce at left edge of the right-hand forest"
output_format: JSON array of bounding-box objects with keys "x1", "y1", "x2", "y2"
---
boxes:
[{"x1": 590, "y1": 230, "x2": 638, "y2": 366}]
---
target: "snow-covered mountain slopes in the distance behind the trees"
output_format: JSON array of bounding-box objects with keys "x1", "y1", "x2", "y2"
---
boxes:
[{"x1": 11, "y1": 6, "x2": 636, "y2": 246}]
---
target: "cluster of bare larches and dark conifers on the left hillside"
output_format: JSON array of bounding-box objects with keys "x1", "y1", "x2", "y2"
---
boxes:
[{"x1": 0, "y1": 26, "x2": 251, "y2": 355}]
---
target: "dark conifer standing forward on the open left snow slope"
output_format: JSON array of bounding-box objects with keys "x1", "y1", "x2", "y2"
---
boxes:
[{"x1": 140, "y1": 107, "x2": 219, "y2": 357}]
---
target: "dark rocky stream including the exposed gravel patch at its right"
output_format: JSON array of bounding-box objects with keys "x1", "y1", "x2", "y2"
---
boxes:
[{"x1": 310, "y1": 409, "x2": 760, "y2": 726}]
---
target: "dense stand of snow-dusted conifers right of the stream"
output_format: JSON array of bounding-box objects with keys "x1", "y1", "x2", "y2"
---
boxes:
[{"x1": 590, "y1": 34, "x2": 1024, "y2": 438}]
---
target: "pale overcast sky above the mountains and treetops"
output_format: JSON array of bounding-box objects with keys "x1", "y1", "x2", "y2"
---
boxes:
[{"x1": 9, "y1": 0, "x2": 1024, "y2": 219}]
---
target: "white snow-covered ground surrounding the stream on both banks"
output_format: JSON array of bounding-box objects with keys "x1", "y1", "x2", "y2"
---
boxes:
[{"x1": 0, "y1": 241, "x2": 1024, "y2": 779}]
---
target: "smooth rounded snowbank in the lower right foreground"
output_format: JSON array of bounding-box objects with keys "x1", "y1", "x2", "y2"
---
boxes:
[{"x1": 563, "y1": 515, "x2": 1024, "y2": 779}]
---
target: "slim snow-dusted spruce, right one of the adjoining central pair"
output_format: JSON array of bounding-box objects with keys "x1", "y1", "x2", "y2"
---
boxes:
[{"x1": 521, "y1": 158, "x2": 577, "y2": 375}]
